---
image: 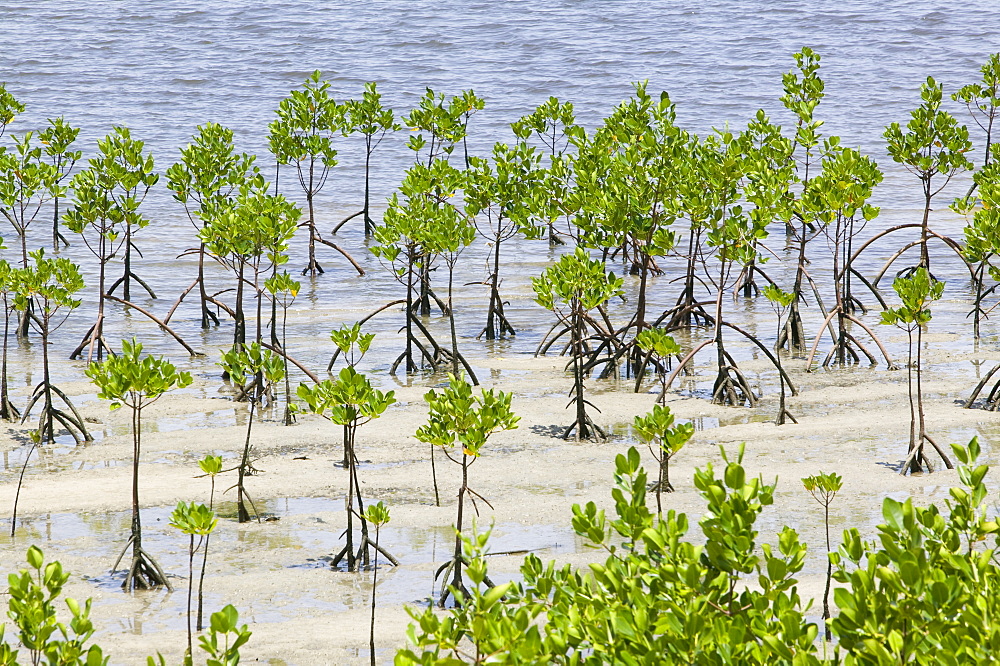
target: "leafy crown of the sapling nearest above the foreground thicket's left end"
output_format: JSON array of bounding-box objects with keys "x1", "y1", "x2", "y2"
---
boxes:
[{"x1": 415, "y1": 375, "x2": 521, "y2": 457}]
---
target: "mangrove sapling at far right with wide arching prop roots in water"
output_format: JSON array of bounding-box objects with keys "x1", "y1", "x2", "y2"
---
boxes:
[{"x1": 872, "y1": 77, "x2": 972, "y2": 286}]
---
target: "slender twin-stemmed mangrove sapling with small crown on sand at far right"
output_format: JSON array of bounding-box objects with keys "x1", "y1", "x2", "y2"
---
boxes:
[{"x1": 881, "y1": 266, "x2": 952, "y2": 475}]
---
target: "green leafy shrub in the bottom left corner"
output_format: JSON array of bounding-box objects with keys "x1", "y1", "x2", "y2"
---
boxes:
[{"x1": 6, "y1": 546, "x2": 108, "y2": 666}]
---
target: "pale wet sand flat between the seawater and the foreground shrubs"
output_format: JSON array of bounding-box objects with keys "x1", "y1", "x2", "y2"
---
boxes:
[{"x1": 0, "y1": 334, "x2": 1000, "y2": 664}]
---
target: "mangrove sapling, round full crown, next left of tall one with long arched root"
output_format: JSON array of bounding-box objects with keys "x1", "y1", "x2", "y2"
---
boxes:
[{"x1": 164, "y1": 123, "x2": 258, "y2": 328}]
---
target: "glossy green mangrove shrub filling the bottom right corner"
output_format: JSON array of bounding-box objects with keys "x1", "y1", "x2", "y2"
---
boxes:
[{"x1": 832, "y1": 439, "x2": 1000, "y2": 665}]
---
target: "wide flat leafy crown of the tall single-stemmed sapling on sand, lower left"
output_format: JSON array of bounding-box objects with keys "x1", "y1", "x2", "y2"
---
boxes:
[{"x1": 86, "y1": 338, "x2": 192, "y2": 410}]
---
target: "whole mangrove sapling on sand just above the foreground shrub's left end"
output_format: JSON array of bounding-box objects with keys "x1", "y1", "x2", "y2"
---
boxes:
[{"x1": 415, "y1": 375, "x2": 520, "y2": 608}]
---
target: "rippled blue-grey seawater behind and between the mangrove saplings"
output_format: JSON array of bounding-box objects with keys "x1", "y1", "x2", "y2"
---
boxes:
[{"x1": 0, "y1": 0, "x2": 1000, "y2": 388}]
